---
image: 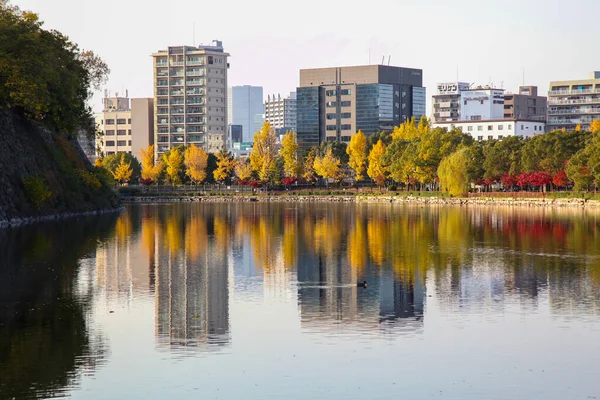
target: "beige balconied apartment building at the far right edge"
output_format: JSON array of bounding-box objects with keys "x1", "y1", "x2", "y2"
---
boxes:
[{"x1": 548, "y1": 71, "x2": 600, "y2": 131}]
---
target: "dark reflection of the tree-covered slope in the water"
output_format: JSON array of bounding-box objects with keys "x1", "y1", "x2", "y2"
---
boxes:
[{"x1": 0, "y1": 217, "x2": 116, "y2": 399}]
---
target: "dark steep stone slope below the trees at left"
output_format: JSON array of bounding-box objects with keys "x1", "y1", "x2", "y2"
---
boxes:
[{"x1": 0, "y1": 110, "x2": 119, "y2": 227}]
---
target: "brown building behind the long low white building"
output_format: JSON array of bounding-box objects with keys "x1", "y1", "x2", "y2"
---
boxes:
[{"x1": 504, "y1": 86, "x2": 547, "y2": 121}]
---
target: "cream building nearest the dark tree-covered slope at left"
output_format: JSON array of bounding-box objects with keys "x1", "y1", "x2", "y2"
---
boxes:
[{"x1": 95, "y1": 93, "x2": 154, "y2": 158}]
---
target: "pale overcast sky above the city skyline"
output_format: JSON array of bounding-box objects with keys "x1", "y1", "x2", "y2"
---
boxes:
[{"x1": 12, "y1": 0, "x2": 600, "y2": 112}]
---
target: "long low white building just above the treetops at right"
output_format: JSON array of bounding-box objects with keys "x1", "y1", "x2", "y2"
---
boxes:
[{"x1": 434, "y1": 119, "x2": 546, "y2": 140}]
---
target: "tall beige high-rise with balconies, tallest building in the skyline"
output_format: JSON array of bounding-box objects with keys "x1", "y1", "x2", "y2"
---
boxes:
[{"x1": 152, "y1": 40, "x2": 229, "y2": 158}]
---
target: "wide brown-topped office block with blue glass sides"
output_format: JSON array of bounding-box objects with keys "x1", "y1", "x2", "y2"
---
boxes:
[{"x1": 296, "y1": 65, "x2": 425, "y2": 148}]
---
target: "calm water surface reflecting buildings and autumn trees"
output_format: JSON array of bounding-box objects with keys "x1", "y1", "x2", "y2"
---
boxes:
[{"x1": 0, "y1": 203, "x2": 600, "y2": 399}]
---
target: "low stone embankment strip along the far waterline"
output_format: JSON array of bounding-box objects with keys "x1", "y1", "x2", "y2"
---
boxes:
[{"x1": 122, "y1": 194, "x2": 600, "y2": 208}]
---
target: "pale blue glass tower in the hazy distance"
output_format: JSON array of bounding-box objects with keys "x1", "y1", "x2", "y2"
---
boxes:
[{"x1": 230, "y1": 85, "x2": 265, "y2": 142}]
